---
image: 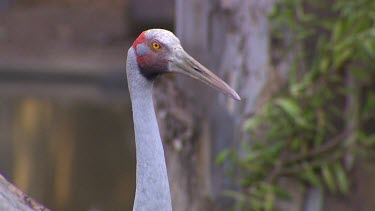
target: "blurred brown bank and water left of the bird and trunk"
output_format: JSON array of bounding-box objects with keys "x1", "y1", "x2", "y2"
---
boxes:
[{"x1": 0, "y1": 0, "x2": 174, "y2": 210}]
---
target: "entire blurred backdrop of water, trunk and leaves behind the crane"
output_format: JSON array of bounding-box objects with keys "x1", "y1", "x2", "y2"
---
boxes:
[{"x1": 0, "y1": 0, "x2": 375, "y2": 211}]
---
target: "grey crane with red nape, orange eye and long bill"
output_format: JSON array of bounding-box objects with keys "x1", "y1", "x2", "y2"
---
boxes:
[{"x1": 126, "y1": 29, "x2": 240, "y2": 211}]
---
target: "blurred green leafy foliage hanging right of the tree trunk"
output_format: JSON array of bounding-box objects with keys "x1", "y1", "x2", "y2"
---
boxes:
[{"x1": 218, "y1": 0, "x2": 375, "y2": 210}]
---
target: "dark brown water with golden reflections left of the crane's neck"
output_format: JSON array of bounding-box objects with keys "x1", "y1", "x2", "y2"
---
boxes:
[{"x1": 0, "y1": 97, "x2": 135, "y2": 211}]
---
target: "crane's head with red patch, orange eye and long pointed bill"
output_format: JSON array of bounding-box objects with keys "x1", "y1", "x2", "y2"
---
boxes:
[{"x1": 132, "y1": 29, "x2": 240, "y2": 100}]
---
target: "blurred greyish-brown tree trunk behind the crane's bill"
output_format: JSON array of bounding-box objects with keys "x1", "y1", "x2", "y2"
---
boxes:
[{"x1": 156, "y1": 0, "x2": 296, "y2": 211}]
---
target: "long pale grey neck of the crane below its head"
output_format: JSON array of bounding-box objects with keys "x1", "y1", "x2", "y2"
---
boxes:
[{"x1": 126, "y1": 47, "x2": 172, "y2": 211}]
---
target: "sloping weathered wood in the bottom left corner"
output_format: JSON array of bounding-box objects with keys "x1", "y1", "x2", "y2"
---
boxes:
[{"x1": 0, "y1": 174, "x2": 49, "y2": 211}]
